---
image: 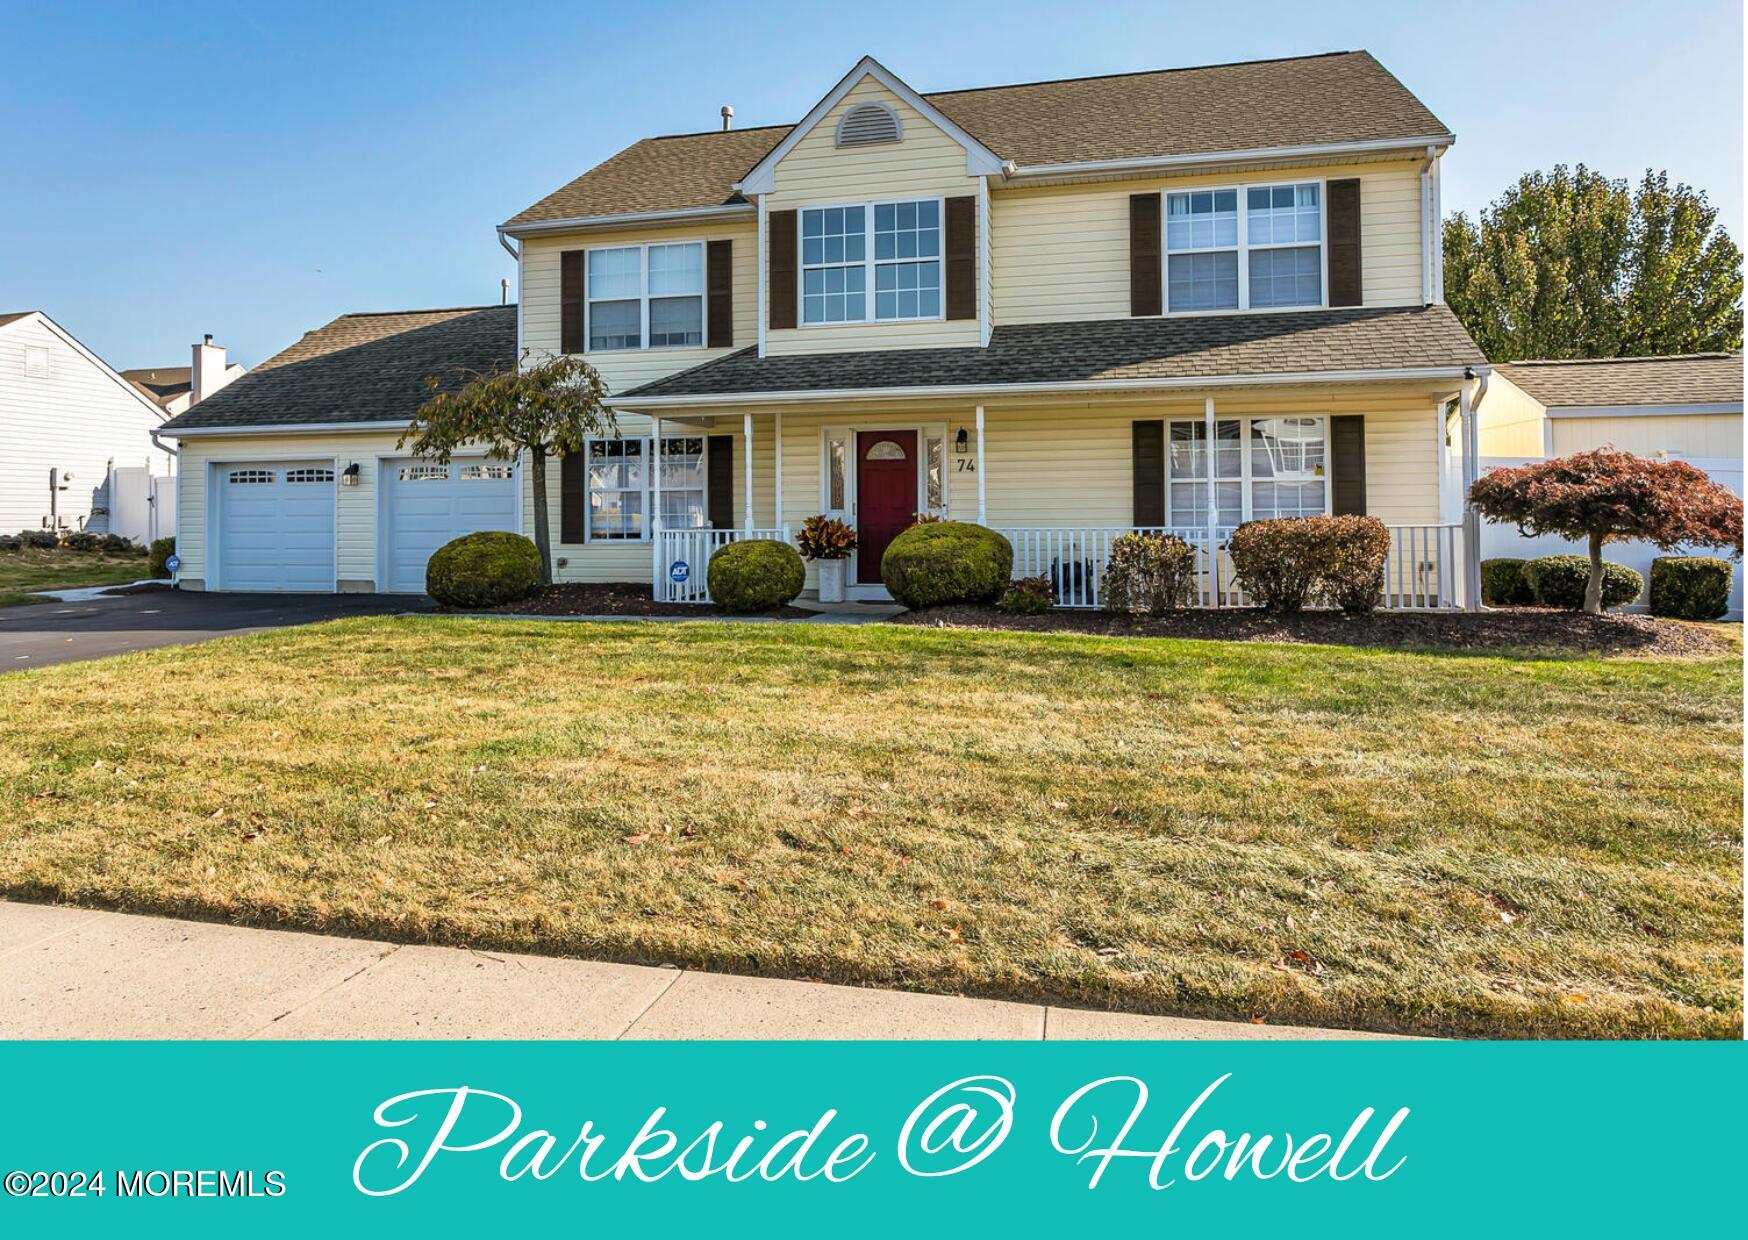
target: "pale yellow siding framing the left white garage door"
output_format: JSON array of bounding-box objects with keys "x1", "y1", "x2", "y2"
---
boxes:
[{"x1": 177, "y1": 432, "x2": 404, "y2": 584}]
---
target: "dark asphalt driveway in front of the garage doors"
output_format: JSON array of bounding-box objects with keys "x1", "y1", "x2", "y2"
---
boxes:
[{"x1": 0, "y1": 589, "x2": 434, "y2": 672}]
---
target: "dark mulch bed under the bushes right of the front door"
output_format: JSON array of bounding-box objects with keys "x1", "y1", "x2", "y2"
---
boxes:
[{"x1": 891, "y1": 607, "x2": 1739, "y2": 658}]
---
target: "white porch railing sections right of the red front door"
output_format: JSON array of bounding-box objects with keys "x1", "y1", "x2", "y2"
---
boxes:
[{"x1": 1000, "y1": 525, "x2": 1461, "y2": 610}]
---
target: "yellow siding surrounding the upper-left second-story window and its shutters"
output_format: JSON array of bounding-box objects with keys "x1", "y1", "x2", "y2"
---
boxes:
[{"x1": 521, "y1": 220, "x2": 759, "y2": 392}]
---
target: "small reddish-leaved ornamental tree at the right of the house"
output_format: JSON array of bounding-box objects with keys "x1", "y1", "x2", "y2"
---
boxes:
[{"x1": 1468, "y1": 448, "x2": 1743, "y2": 616}]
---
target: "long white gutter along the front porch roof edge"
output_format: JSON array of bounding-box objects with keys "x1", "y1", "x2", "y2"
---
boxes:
[{"x1": 612, "y1": 366, "x2": 1486, "y2": 413}]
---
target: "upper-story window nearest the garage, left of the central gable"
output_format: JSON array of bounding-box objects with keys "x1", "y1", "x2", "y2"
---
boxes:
[{"x1": 584, "y1": 241, "x2": 704, "y2": 352}]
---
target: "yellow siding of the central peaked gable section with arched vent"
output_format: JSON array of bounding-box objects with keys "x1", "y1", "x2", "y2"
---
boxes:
[{"x1": 766, "y1": 77, "x2": 981, "y2": 355}]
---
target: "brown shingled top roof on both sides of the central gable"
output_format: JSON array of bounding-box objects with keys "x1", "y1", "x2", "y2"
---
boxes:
[{"x1": 505, "y1": 51, "x2": 1447, "y2": 227}]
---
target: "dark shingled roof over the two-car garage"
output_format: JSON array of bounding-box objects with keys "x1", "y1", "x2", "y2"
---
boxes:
[{"x1": 163, "y1": 306, "x2": 516, "y2": 434}]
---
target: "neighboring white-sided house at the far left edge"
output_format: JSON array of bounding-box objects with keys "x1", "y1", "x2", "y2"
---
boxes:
[{"x1": 0, "y1": 310, "x2": 175, "y2": 537}]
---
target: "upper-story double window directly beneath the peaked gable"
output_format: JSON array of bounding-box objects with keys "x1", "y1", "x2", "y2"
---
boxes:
[{"x1": 801, "y1": 198, "x2": 940, "y2": 325}]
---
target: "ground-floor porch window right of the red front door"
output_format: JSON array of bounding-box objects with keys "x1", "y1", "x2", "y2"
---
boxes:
[{"x1": 1166, "y1": 416, "x2": 1328, "y2": 530}]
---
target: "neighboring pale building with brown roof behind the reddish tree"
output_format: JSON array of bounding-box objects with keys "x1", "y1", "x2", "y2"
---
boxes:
[{"x1": 1477, "y1": 353, "x2": 1743, "y2": 619}]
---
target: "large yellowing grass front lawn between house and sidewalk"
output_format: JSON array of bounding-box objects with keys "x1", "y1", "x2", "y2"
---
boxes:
[{"x1": 0, "y1": 617, "x2": 1743, "y2": 1037}]
